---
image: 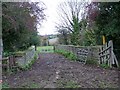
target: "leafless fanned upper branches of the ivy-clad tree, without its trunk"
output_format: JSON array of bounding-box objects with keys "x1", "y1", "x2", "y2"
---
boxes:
[{"x1": 57, "y1": 0, "x2": 85, "y2": 32}]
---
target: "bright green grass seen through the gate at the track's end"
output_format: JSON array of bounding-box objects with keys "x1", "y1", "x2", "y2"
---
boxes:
[{"x1": 37, "y1": 46, "x2": 54, "y2": 53}]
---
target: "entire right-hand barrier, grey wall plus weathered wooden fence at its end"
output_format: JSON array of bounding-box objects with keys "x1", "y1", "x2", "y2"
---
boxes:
[{"x1": 54, "y1": 41, "x2": 119, "y2": 67}]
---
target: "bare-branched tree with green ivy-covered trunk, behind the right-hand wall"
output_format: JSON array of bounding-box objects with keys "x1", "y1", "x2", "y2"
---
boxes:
[{"x1": 57, "y1": 0, "x2": 86, "y2": 45}]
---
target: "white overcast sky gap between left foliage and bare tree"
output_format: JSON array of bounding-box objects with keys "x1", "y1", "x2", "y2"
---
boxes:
[{"x1": 38, "y1": 0, "x2": 64, "y2": 35}]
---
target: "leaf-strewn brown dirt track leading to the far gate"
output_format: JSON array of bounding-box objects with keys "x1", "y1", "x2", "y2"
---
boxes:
[{"x1": 3, "y1": 53, "x2": 118, "y2": 88}]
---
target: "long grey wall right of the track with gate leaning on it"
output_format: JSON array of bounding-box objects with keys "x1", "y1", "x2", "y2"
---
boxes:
[{"x1": 54, "y1": 45, "x2": 99, "y2": 63}]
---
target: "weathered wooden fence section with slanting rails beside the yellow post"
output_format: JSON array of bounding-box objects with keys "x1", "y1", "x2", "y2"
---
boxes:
[{"x1": 99, "y1": 40, "x2": 119, "y2": 67}]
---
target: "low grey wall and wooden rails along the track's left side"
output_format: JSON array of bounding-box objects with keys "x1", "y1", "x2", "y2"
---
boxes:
[{"x1": 2, "y1": 47, "x2": 35, "y2": 71}]
